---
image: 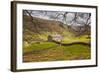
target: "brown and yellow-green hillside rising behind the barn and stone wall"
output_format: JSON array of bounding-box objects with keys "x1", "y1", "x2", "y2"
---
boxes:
[{"x1": 23, "y1": 15, "x2": 90, "y2": 43}]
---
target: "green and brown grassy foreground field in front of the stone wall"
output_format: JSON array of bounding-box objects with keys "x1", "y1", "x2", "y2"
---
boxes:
[{"x1": 23, "y1": 42, "x2": 91, "y2": 62}]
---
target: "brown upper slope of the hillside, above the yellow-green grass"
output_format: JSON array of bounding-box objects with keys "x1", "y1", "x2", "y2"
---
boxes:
[{"x1": 23, "y1": 16, "x2": 67, "y2": 33}]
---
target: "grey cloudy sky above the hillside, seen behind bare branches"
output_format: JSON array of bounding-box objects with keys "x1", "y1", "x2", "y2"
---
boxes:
[{"x1": 23, "y1": 10, "x2": 91, "y2": 25}]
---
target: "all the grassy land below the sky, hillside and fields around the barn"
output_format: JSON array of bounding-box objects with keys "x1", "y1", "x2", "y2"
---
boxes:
[{"x1": 23, "y1": 15, "x2": 91, "y2": 62}]
